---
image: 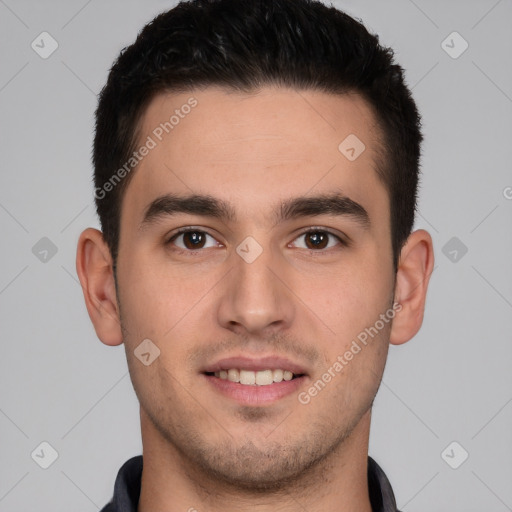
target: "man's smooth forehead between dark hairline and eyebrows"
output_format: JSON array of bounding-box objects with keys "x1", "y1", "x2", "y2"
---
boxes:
[{"x1": 123, "y1": 87, "x2": 387, "y2": 225}]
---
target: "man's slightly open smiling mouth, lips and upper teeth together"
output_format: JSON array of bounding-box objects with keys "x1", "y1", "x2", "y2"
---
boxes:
[{"x1": 202, "y1": 357, "x2": 308, "y2": 405}]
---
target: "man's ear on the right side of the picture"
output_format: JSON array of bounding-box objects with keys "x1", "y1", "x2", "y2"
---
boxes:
[{"x1": 389, "y1": 229, "x2": 434, "y2": 345}]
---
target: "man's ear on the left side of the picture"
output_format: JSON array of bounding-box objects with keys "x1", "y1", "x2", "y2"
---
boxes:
[{"x1": 76, "y1": 228, "x2": 123, "y2": 345}]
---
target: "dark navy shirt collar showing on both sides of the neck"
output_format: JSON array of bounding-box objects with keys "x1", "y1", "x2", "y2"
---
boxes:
[{"x1": 101, "y1": 455, "x2": 400, "y2": 512}]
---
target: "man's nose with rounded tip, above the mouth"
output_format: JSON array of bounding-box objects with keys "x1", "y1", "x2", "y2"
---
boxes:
[{"x1": 218, "y1": 240, "x2": 296, "y2": 337}]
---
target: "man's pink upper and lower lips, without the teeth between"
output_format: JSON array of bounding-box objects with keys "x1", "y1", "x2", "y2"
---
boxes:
[{"x1": 201, "y1": 356, "x2": 308, "y2": 406}]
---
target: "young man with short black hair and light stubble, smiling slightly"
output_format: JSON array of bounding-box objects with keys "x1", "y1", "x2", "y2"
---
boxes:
[{"x1": 77, "y1": 0, "x2": 433, "y2": 512}]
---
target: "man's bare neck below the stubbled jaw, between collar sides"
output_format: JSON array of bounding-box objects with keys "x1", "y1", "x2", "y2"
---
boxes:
[{"x1": 138, "y1": 410, "x2": 371, "y2": 512}]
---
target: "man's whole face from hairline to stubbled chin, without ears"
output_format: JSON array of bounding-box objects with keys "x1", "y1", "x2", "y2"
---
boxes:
[{"x1": 117, "y1": 88, "x2": 395, "y2": 487}]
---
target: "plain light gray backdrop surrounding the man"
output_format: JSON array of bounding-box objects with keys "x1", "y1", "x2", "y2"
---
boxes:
[{"x1": 0, "y1": 0, "x2": 512, "y2": 512}]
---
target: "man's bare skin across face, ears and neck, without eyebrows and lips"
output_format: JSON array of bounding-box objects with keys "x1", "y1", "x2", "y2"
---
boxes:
[{"x1": 77, "y1": 87, "x2": 434, "y2": 512}]
